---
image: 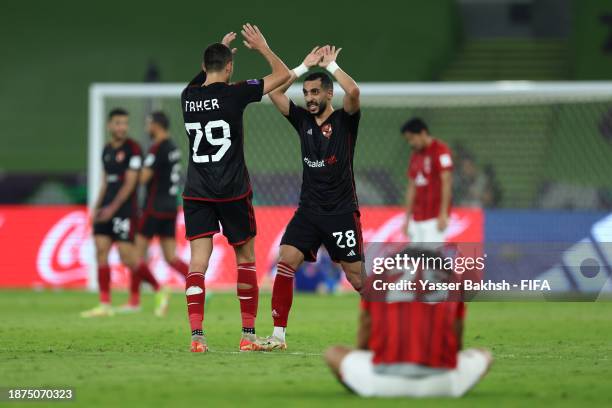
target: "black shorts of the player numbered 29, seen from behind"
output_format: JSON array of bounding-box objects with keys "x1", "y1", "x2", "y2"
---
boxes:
[{"x1": 183, "y1": 194, "x2": 257, "y2": 245}]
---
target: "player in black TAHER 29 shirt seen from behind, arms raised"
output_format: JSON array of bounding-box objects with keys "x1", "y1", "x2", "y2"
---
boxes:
[{"x1": 181, "y1": 24, "x2": 289, "y2": 352}]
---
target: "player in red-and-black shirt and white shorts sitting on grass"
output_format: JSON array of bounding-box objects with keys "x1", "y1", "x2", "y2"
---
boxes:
[{"x1": 325, "y1": 248, "x2": 492, "y2": 397}]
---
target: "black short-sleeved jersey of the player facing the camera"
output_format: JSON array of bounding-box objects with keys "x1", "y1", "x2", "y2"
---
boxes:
[{"x1": 287, "y1": 102, "x2": 361, "y2": 214}]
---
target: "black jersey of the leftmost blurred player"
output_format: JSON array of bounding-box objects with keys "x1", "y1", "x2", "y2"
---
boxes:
[{"x1": 102, "y1": 138, "x2": 142, "y2": 216}]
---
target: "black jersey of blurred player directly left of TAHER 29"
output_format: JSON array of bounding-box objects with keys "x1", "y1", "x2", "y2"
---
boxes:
[{"x1": 143, "y1": 139, "x2": 181, "y2": 216}]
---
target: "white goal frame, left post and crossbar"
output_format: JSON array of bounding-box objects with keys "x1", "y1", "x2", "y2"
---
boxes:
[{"x1": 87, "y1": 81, "x2": 612, "y2": 209}]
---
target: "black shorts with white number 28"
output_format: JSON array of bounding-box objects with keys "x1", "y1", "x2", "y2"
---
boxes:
[{"x1": 281, "y1": 208, "x2": 363, "y2": 262}]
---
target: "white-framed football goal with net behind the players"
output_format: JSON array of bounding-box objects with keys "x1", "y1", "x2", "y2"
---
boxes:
[{"x1": 88, "y1": 81, "x2": 612, "y2": 290}]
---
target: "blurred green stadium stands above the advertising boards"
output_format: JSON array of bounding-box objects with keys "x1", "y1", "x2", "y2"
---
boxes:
[{"x1": 0, "y1": 0, "x2": 612, "y2": 210}]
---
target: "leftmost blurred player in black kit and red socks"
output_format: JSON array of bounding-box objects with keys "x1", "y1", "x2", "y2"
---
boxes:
[{"x1": 81, "y1": 108, "x2": 157, "y2": 317}]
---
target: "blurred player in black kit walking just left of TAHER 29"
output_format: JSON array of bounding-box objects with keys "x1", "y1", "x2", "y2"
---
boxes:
[{"x1": 117, "y1": 111, "x2": 189, "y2": 316}]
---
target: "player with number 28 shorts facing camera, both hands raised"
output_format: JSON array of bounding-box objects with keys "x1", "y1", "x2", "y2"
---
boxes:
[{"x1": 262, "y1": 46, "x2": 364, "y2": 350}]
